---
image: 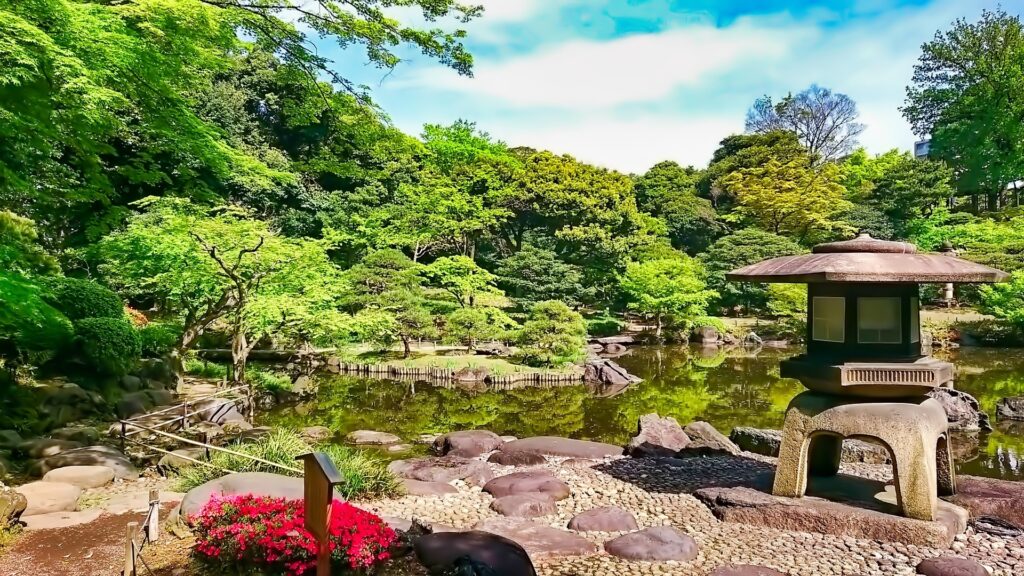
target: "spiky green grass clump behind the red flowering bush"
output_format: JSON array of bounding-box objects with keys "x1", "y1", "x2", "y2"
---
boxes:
[{"x1": 177, "y1": 429, "x2": 401, "y2": 499}]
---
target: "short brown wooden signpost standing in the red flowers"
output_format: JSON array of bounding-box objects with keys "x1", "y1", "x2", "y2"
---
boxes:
[{"x1": 297, "y1": 452, "x2": 342, "y2": 576}]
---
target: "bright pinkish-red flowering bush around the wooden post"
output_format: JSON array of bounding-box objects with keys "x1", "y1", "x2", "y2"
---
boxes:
[{"x1": 189, "y1": 494, "x2": 395, "y2": 576}]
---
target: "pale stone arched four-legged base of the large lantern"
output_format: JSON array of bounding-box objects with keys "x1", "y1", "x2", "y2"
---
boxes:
[{"x1": 772, "y1": 392, "x2": 955, "y2": 521}]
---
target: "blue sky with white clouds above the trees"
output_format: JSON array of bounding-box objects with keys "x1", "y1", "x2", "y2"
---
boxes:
[{"x1": 321, "y1": 0, "x2": 1024, "y2": 172}]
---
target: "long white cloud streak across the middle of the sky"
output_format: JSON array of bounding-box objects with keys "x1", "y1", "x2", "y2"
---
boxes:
[{"x1": 404, "y1": 19, "x2": 814, "y2": 110}]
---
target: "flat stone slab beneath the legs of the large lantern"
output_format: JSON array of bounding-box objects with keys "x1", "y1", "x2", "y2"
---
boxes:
[{"x1": 693, "y1": 488, "x2": 968, "y2": 548}]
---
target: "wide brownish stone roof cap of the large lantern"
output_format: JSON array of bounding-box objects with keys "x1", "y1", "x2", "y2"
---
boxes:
[{"x1": 726, "y1": 229, "x2": 1010, "y2": 284}]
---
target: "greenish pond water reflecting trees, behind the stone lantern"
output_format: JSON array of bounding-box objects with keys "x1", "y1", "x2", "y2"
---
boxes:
[{"x1": 262, "y1": 346, "x2": 1024, "y2": 480}]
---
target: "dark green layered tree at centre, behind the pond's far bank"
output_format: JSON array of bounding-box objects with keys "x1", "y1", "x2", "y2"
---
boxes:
[{"x1": 496, "y1": 244, "x2": 585, "y2": 308}]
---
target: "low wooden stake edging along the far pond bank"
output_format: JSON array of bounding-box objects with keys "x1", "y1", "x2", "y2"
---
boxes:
[{"x1": 329, "y1": 362, "x2": 583, "y2": 386}]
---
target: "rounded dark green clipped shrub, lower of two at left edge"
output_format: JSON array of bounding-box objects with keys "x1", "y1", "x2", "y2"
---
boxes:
[{"x1": 75, "y1": 317, "x2": 142, "y2": 375}]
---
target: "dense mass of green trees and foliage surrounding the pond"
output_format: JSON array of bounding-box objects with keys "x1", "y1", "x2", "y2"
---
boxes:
[{"x1": 0, "y1": 0, "x2": 1024, "y2": 379}]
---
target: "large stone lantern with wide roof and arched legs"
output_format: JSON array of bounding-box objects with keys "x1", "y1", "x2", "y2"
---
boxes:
[{"x1": 727, "y1": 234, "x2": 1008, "y2": 520}]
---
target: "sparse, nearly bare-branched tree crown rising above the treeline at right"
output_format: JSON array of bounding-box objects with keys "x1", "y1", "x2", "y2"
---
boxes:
[{"x1": 746, "y1": 84, "x2": 864, "y2": 161}]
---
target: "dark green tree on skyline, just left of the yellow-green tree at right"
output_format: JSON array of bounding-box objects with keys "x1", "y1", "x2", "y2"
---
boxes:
[{"x1": 635, "y1": 162, "x2": 724, "y2": 254}]
